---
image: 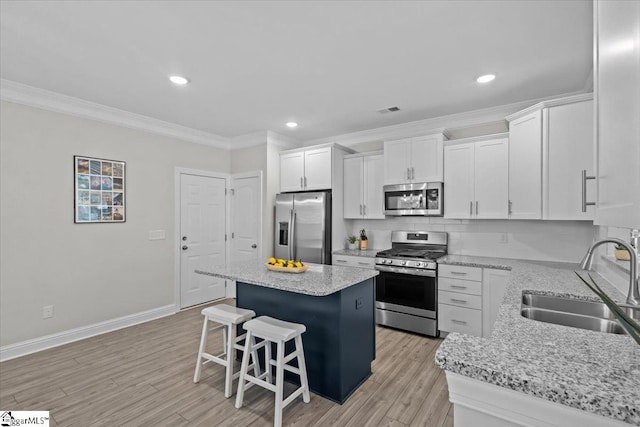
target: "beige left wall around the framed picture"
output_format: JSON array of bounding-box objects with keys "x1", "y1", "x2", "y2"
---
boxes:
[{"x1": 0, "y1": 102, "x2": 230, "y2": 346}]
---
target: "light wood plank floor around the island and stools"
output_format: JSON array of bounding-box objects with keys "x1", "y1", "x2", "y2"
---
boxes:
[{"x1": 0, "y1": 301, "x2": 453, "y2": 427}]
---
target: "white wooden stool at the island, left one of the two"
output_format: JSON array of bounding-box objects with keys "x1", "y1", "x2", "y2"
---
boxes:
[{"x1": 193, "y1": 304, "x2": 264, "y2": 398}]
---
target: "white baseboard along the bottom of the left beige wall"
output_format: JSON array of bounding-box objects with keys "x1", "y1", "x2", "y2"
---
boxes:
[{"x1": 0, "y1": 304, "x2": 176, "y2": 362}]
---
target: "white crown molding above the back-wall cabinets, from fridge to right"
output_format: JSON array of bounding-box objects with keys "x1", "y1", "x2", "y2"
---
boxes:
[{"x1": 303, "y1": 92, "x2": 590, "y2": 147}]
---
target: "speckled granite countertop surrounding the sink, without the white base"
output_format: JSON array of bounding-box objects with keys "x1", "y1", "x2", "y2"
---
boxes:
[{"x1": 436, "y1": 256, "x2": 640, "y2": 425}]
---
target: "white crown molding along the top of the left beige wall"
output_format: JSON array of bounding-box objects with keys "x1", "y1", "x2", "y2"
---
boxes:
[{"x1": 0, "y1": 79, "x2": 230, "y2": 150}]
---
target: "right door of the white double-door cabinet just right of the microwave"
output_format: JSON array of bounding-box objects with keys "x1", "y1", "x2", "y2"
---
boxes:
[{"x1": 476, "y1": 138, "x2": 509, "y2": 219}]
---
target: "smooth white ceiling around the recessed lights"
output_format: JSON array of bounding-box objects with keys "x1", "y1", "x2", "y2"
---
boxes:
[{"x1": 0, "y1": 0, "x2": 592, "y2": 141}]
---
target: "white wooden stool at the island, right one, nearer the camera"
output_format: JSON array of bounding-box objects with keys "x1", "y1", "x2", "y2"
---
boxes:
[{"x1": 236, "y1": 316, "x2": 310, "y2": 427}]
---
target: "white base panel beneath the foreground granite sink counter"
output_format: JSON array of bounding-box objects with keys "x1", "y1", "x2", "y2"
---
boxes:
[{"x1": 445, "y1": 371, "x2": 628, "y2": 427}]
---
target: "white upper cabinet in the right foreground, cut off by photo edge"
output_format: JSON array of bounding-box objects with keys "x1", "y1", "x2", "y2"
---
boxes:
[{"x1": 594, "y1": 1, "x2": 640, "y2": 228}]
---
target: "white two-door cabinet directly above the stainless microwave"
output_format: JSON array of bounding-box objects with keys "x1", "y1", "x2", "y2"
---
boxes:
[{"x1": 384, "y1": 133, "x2": 444, "y2": 184}]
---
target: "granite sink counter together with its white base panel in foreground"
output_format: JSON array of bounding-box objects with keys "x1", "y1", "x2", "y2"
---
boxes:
[{"x1": 436, "y1": 255, "x2": 640, "y2": 426}]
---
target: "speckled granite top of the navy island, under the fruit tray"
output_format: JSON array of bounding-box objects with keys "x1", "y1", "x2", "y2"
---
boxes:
[{"x1": 196, "y1": 261, "x2": 379, "y2": 296}]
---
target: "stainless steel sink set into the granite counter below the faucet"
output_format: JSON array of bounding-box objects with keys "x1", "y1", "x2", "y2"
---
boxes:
[{"x1": 520, "y1": 292, "x2": 626, "y2": 334}]
